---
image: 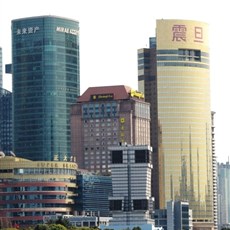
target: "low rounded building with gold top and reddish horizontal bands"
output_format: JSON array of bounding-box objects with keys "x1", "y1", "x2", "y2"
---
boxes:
[{"x1": 0, "y1": 154, "x2": 77, "y2": 226}]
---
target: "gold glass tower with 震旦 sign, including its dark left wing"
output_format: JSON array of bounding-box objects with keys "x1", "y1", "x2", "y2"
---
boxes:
[{"x1": 138, "y1": 19, "x2": 214, "y2": 229}]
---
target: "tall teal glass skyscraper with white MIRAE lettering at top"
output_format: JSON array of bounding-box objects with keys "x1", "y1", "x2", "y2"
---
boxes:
[{"x1": 12, "y1": 16, "x2": 80, "y2": 161}]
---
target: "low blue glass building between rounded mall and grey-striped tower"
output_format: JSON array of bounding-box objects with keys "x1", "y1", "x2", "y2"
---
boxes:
[{"x1": 74, "y1": 170, "x2": 112, "y2": 217}]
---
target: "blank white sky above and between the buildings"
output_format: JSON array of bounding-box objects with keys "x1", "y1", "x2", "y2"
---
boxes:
[{"x1": 0, "y1": 0, "x2": 230, "y2": 163}]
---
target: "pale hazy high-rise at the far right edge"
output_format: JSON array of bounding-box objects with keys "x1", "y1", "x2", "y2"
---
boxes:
[{"x1": 217, "y1": 161, "x2": 230, "y2": 229}]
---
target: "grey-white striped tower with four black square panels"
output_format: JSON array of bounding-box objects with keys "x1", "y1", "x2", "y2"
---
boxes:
[{"x1": 102, "y1": 144, "x2": 155, "y2": 230}]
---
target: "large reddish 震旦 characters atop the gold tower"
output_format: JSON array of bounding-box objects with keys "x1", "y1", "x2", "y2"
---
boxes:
[{"x1": 172, "y1": 25, "x2": 203, "y2": 43}]
